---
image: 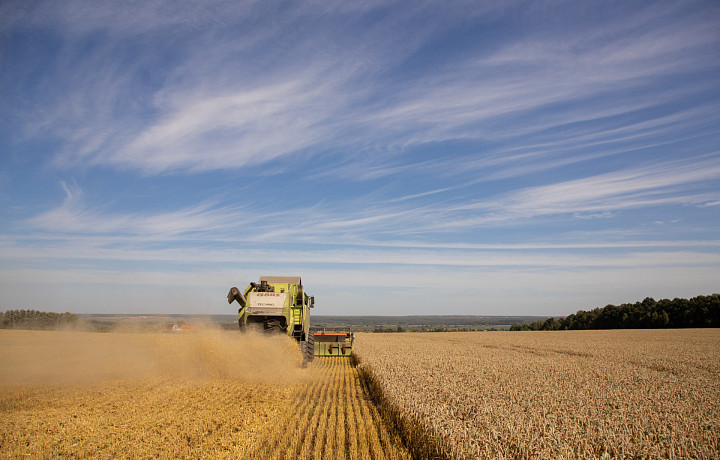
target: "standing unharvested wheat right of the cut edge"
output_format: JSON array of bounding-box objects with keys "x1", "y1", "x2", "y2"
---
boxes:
[{"x1": 355, "y1": 329, "x2": 720, "y2": 458}]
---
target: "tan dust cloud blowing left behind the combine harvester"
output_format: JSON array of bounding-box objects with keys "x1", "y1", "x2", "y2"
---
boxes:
[{"x1": 0, "y1": 330, "x2": 303, "y2": 385}]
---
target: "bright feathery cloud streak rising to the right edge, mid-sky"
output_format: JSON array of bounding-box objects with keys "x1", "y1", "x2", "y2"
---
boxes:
[{"x1": 300, "y1": 155, "x2": 720, "y2": 234}]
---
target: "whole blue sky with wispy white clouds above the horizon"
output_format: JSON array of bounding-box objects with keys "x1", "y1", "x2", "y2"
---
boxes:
[{"x1": 0, "y1": 0, "x2": 720, "y2": 316}]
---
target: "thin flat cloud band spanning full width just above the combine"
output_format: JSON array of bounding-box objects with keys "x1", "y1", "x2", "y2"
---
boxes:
[{"x1": 5, "y1": 238, "x2": 720, "y2": 271}]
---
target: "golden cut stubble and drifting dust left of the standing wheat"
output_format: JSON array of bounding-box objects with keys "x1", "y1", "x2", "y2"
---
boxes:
[{"x1": 0, "y1": 331, "x2": 409, "y2": 459}]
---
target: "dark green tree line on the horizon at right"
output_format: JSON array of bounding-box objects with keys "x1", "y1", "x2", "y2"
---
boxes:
[{"x1": 510, "y1": 294, "x2": 720, "y2": 331}]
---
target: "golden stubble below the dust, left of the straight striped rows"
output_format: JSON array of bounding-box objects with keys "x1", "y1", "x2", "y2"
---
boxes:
[{"x1": 0, "y1": 380, "x2": 289, "y2": 458}]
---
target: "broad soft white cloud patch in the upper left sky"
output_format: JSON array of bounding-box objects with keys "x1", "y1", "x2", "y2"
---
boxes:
[{"x1": 109, "y1": 76, "x2": 340, "y2": 172}]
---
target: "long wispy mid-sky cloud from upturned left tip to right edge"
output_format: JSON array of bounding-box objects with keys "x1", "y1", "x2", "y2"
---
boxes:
[{"x1": 19, "y1": 151, "x2": 720, "y2": 245}]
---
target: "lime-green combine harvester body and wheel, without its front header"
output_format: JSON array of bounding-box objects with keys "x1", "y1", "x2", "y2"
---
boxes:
[{"x1": 228, "y1": 276, "x2": 315, "y2": 361}]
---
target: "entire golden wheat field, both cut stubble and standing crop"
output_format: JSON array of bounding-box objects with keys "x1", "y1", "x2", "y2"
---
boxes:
[{"x1": 0, "y1": 329, "x2": 720, "y2": 459}]
